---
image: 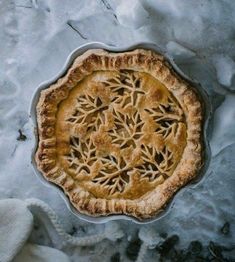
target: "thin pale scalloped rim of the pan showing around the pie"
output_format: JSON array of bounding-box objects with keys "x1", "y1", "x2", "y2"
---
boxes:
[{"x1": 30, "y1": 43, "x2": 210, "y2": 223}]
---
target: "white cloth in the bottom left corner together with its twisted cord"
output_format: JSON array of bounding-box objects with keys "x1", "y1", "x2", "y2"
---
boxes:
[{"x1": 0, "y1": 198, "x2": 124, "y2": 262}]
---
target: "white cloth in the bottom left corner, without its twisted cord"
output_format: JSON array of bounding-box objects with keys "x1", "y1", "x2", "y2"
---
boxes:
[{"x1": 0, "y1": 199, "x2": 69, "y2": 262}]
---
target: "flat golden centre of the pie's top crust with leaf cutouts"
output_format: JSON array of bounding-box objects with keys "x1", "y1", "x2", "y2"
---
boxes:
[{"x1": 64, "y1": 71, "x2": 186, "y2": 197}]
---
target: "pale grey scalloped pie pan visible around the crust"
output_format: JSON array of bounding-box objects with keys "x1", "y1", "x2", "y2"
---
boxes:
[{"x1": 29, "y1": 42, "x2": 211, "y2": 224}]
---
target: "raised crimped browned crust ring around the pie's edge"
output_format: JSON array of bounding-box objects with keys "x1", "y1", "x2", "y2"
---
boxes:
[{"x1": 35, "y1": 49, "x2": 202, "y2": 219}]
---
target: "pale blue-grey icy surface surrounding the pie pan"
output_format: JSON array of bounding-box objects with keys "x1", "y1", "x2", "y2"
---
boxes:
[{"x1": 0, "y1": 0, "x2": 235, "y2": 261}]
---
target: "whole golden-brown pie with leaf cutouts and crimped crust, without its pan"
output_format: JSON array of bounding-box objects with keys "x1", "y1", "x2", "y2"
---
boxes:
[{"x1": 35, "y1": 49, "x2": 203, "y2": 219}]
